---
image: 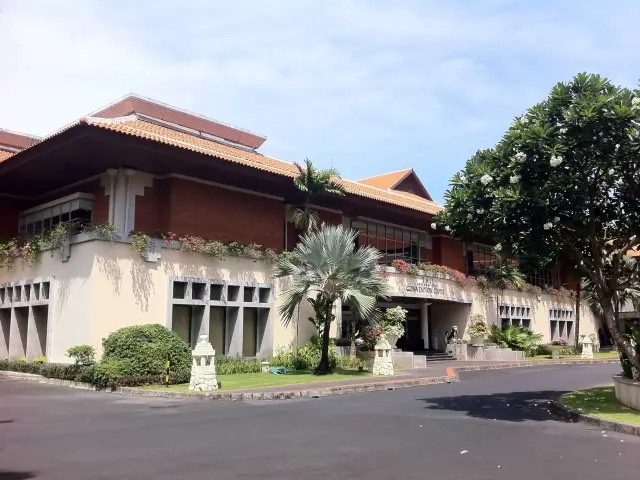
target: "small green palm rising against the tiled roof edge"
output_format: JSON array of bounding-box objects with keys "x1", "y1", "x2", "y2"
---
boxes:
[{"x1": 291, "y1": 158, "x2": 344, "y2": 232}]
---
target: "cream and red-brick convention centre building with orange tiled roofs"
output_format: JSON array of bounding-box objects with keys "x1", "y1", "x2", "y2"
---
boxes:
[{"x1": 0, "y1": 95, "x2": 596, "y2": 362}]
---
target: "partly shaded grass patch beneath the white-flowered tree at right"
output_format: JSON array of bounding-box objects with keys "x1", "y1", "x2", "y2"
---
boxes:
[{"x1": 560, "y1": 386, "x2": 640, "y2": 425}]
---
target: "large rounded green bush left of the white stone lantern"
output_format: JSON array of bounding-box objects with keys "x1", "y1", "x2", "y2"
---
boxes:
[{"x1": 102, "y1": 324, "x2": 191, "y2": 376}]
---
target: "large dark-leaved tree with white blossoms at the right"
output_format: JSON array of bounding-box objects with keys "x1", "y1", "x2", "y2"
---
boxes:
[{"x1": 440, "y1": 74, "x2": 640, "y2": 376}]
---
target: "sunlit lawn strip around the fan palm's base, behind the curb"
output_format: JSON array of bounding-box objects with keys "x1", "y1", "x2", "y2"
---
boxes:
[{"x1": 143, "y1": 369, "x2": 372, "y2": 392}]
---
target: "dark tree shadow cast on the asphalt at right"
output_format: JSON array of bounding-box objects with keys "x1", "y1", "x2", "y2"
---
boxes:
[{"x1": 420, "y1": 390, "x2": 568, "y2": 422}]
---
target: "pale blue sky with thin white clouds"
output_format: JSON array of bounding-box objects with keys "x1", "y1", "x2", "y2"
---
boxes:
[{"x1": 0, "y1": 0, "x2": 640, "y2": 201}]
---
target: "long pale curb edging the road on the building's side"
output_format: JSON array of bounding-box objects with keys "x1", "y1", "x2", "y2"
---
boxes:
[{"x1": 0, "y1": 358, "x2": 626, "y2": 400}]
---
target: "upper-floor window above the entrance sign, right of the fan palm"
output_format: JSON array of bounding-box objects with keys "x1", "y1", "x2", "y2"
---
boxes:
[{"x1": 351, "y1": 220, "x2": 421, "y2": 264}]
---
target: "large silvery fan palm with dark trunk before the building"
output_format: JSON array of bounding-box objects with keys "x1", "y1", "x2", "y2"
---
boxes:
[{"x1": 273, "y1": 225, "x2": 391, "y2": 375}]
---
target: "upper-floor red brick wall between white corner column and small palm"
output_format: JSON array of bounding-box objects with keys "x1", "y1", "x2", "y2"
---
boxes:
[{"x1": 135, "y1": 178, "x2": 285, "y2": 250}]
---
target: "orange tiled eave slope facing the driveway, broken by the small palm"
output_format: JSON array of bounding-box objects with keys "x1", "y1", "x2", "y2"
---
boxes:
[{"x1": 83, "y1": 115, "x2": 442, "y2": 214}]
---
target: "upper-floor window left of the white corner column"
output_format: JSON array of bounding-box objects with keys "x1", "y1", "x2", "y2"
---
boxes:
[{"x1": 18, "y1": 193, "x2": 93, "y2": 237}]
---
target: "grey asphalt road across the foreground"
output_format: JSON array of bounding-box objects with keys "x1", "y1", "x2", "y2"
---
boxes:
[{"x1": 0, "y1": 365, "x2": 640, "y2": 480}]
